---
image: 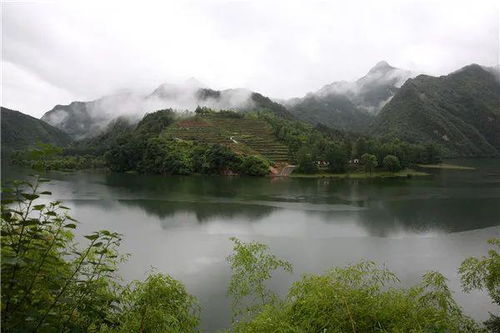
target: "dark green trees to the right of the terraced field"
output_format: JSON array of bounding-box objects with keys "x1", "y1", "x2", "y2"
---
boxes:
[{"x1": 256, "y1": 112, "x2": 441, "y2": 173}]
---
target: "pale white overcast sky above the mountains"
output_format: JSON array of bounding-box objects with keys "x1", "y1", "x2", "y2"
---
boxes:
[{"x1": 2, "y1": 0, "x2": 499, "y2": 117}]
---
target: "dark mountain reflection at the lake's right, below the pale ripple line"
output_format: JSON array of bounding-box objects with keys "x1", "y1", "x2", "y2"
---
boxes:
[{"x1": 312, "y1": 198, "x2": 500, "y2": 237}]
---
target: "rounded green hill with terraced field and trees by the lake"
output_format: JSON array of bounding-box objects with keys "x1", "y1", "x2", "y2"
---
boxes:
[{"x1": 94, "y1": 108, "x2": 288, "y2": 176}]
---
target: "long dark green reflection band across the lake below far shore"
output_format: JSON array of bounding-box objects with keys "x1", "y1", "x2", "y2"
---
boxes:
[{"x1": 47, "y1": 174, "x2": 500, "y2": 237}]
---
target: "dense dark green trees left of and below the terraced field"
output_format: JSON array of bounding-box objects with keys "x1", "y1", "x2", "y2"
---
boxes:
[{"x1": 13, "y1": 107, "x2": 270, "y2": 176}]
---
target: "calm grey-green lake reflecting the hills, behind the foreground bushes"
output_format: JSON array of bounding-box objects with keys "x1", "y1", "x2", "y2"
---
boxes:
[{"x1": 2, "y1": 159, "x2": 500, "y2": 332}]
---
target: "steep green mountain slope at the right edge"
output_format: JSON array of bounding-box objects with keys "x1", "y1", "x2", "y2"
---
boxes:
[{"x1": 371, "y1": 65, "x2": 500, "y2": 157}]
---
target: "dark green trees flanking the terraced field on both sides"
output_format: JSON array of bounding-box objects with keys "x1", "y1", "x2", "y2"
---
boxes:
[{"x1": 10, "y1": 107, "x2": 440, "y2": 176}]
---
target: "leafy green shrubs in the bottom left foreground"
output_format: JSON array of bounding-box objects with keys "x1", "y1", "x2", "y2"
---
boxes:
[{"x1": 1, "y1": 177, "x2": 199, "y2": 332}]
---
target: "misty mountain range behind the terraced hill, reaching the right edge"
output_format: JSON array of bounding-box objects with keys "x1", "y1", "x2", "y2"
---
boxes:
[{"x1": 2, "y1": 61, "x2": 500, "y2": 156}]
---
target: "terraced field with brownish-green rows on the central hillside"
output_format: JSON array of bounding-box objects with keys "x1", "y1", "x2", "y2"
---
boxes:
[{"x1": 163, "y1": 115, "x2": 289, "y2": 163}]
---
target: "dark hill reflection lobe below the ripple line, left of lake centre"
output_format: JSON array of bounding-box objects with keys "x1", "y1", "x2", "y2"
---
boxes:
[{"x1": 119, "y1": 200, "x2": 276, "y2": 223}]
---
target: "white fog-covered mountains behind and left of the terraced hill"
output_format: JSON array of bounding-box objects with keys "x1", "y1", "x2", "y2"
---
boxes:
[{"x1": 41, "y1": 78, "x2": 254, "y2": 139}]
